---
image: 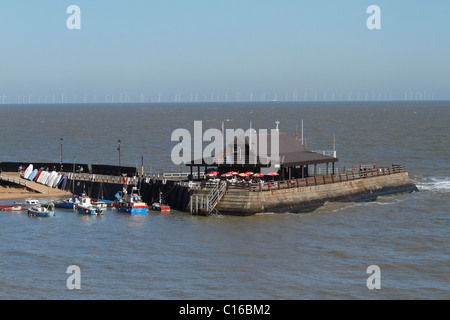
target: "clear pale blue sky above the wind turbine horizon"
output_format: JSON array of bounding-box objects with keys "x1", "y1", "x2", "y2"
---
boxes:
[{"x1": 0, "y1": 0, "x2": 450, "y2": 103}]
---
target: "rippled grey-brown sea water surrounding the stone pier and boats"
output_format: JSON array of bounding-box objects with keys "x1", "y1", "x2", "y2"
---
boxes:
[{"x1": 0, "y1": 102, "x2": 450, "y2": 300}]
